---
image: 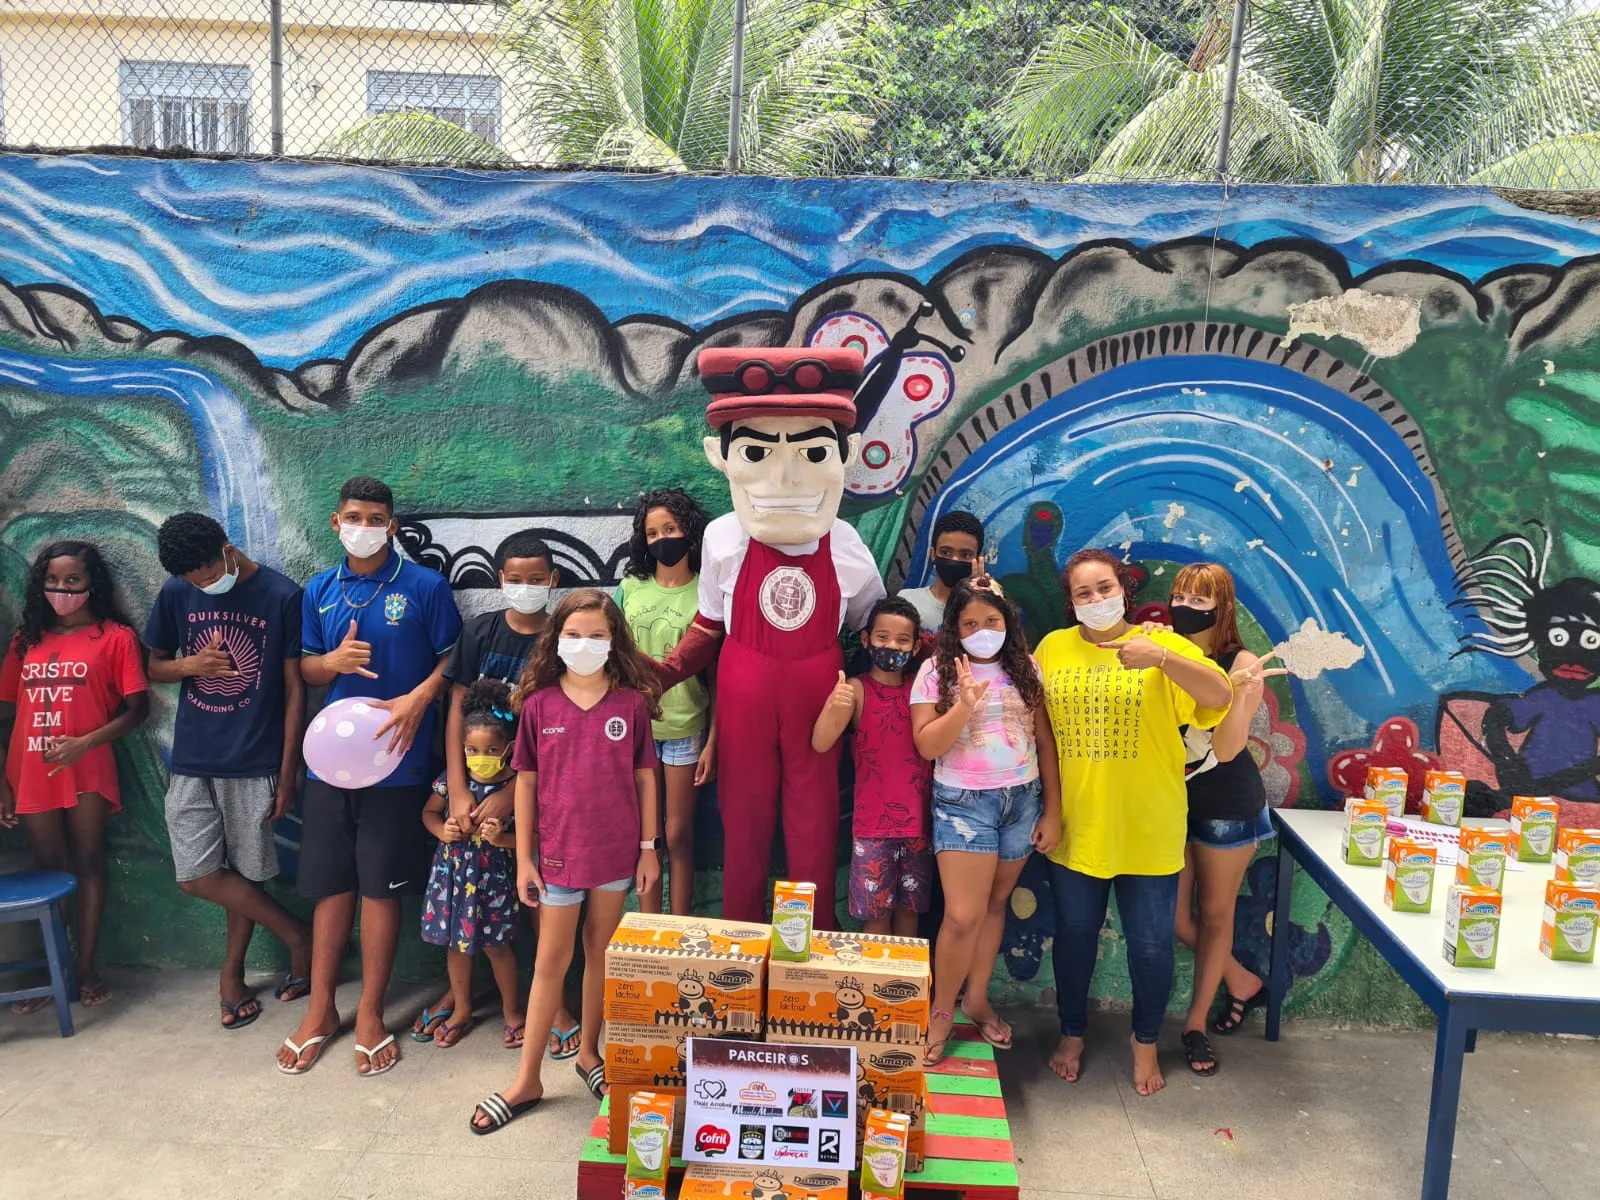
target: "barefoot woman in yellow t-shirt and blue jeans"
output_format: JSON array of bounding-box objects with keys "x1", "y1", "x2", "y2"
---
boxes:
[{"x1": 1035, "y1": 550, "x2": 1234, "y2": 1096}]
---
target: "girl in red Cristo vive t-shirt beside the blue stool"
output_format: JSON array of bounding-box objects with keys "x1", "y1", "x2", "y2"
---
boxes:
[{"x1": 0, "y1": 541, "x2": 150, "y2": 1013}]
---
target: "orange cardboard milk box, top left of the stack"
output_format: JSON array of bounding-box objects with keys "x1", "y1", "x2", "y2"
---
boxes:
[{"x1": 605, "y1": 912, "x2": 771, "y2": 1036}]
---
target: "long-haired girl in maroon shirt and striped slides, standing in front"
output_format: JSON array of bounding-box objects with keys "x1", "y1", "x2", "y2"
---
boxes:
[{"x1": 470, "y1": 589, "x2": 661, "y2": 1133}]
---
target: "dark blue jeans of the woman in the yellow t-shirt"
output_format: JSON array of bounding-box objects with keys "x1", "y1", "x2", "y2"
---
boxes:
[{"x1": 1050, "y1": 862, "x2": 1178, "y2": 1046}]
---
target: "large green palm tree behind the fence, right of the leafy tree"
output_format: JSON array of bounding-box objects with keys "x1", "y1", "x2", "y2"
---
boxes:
[{"x1": 998, "y1": 0, "x2": 1600, "y2": 187}]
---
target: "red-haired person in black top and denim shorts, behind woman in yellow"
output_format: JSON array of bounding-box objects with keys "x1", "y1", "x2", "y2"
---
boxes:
[{"x1": 1170, "y1": 563, "x2": 1283, "y2": 1075}]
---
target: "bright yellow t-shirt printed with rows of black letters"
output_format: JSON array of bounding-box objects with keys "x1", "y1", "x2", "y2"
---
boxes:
[{"x1": 1034, "y1": 627, "x2": 1227, "y2": 878}]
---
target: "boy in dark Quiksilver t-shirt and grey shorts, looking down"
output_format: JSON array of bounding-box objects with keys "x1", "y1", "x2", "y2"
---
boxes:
[{"x1": 144, "y1": 512, "x2": 310, "y2": 1029}]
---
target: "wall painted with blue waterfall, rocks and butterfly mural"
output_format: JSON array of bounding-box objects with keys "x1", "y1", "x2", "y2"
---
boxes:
[{"x1": 0, "y1": 157, "x2": 1600, "y2": 1016}]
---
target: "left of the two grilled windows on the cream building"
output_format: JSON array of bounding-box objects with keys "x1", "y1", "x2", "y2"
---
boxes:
[{"x1": 122, "y1": 62, "x2": 250, "y2": 154}]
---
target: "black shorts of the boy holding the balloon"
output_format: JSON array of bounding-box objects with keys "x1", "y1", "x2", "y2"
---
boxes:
[{"x1": 298, "y1": 779, "x2": 432, "y2": 899}]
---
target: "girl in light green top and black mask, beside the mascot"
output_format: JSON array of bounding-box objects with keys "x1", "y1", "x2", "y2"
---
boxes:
[{"x1": 616, "y1": 488, "x2": 717, "y2": 915}]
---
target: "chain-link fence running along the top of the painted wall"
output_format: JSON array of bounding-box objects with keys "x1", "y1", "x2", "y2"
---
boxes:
[{"x1": 0, "y1": 0, "x2": 1600, "y2": 190}]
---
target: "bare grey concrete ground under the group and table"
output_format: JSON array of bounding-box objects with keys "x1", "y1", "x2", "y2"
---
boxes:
[{"x1": 0, "y1": 971, "x2": 1600, "y2": 1200}]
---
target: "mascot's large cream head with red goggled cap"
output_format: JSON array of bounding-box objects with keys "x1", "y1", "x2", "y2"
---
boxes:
[{"x1": 699, "y1": 346, "x2": 864, "y2": 546}]
